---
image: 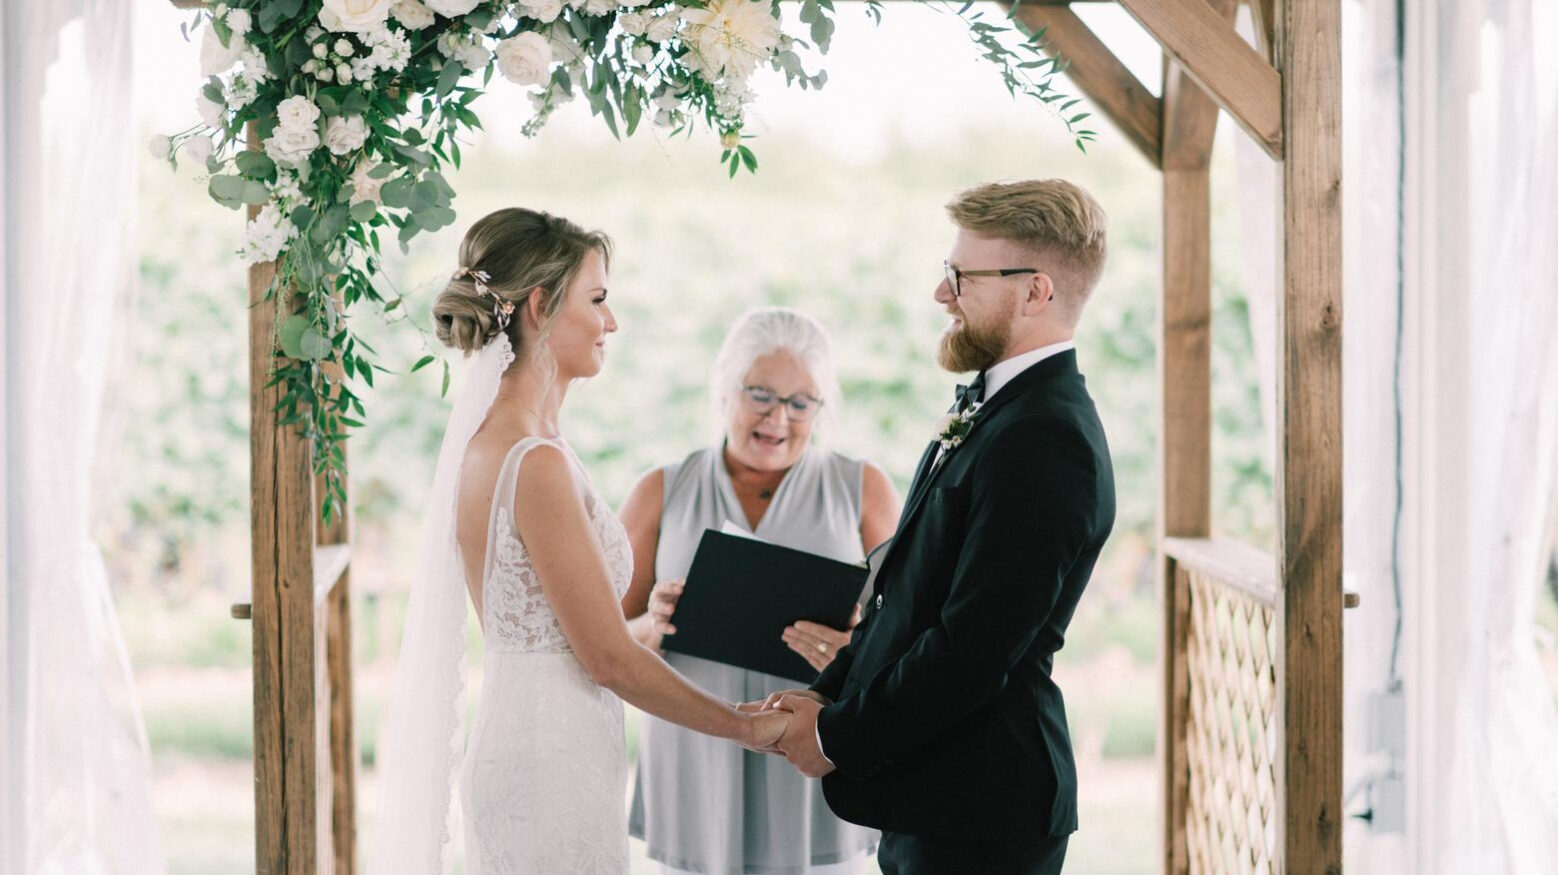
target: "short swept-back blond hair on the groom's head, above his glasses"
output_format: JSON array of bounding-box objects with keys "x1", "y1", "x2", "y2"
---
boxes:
[{"x1": 947, "y1": 179, "x2": 1109, "y2": 325}]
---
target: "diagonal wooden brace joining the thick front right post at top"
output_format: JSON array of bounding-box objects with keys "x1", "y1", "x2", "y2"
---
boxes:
[{"x1": 1120, "y1": 0, "x2": 1284, "y2": 159}]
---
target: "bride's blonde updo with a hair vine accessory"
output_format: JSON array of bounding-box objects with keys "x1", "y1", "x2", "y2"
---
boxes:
[{"x1": 433, "y1": 207, "x2": 611, "y2": 358}]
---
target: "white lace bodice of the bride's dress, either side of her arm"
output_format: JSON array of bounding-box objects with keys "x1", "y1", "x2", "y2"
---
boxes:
[{"x1": 481, "y1": 453, "x2": 633, "y2": 652}]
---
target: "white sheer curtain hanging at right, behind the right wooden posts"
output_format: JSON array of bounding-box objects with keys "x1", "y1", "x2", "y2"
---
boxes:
[{"x1": 1239, "y1": 0, "x2": 1558, "y2": 875}]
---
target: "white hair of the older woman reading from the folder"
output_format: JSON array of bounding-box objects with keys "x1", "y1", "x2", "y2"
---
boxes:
[{"x1": 709, "y1": 307, "x2": 844, "y2": 442}]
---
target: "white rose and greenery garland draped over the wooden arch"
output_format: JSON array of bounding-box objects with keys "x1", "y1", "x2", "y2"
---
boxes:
[{"x1": 151, "y1": 0, "x2": 1094, "y2": 518}]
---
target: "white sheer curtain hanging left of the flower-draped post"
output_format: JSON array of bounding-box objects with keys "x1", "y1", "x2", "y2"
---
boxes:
[{"x1": 0, "y1": 0, "x2": 164, "y2": 875}]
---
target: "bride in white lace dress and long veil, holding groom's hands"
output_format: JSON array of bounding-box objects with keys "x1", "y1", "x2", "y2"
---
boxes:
[{"x1": 369, "y1": 209, "x2": 788, "y2": 875}]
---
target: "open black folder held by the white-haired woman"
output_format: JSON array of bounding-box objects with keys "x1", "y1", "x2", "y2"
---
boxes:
[{"x1": 661, "y1": 529, "x2": 866, "y2": 683}]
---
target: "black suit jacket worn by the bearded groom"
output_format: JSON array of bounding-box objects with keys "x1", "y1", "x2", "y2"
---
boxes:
[{"x1": 812, "y1": 350, "x2": 1114, "y2": 841}]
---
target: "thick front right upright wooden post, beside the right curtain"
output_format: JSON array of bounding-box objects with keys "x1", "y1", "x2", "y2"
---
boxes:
[{"x1": 1276, "y1": 0, "x2": 1343, "y2": 873}]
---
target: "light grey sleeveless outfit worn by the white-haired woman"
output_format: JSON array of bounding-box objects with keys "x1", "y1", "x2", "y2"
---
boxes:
[{"x1": 628, "y1": 447, "x2": 877, "y2": 875}]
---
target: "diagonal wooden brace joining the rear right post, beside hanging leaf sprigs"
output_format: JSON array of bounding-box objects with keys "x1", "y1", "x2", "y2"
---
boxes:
[{"x1": 1002, "y1": 0, "x2": 1162, "y2": 167}]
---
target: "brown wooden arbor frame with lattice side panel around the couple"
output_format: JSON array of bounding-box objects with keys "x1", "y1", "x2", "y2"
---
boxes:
[{"x1": 188, "y1": 0, "x2": 1345, "y2": 875}]
